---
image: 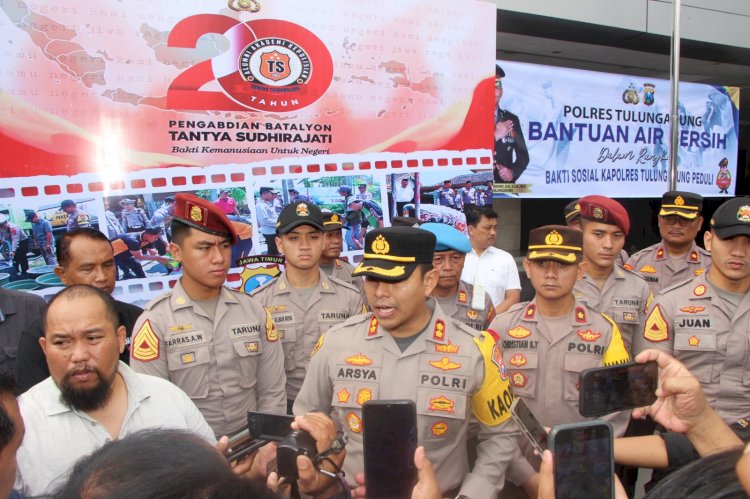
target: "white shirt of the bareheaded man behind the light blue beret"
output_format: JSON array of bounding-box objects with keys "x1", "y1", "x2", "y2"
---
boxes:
[{"x1": 461, "y1": 246, "x2": 521, "y2": 307}]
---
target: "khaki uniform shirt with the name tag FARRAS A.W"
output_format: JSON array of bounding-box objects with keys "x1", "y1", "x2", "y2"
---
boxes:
[{"x1": 130, "y1": 282, "x2": 286, "y2": 437}]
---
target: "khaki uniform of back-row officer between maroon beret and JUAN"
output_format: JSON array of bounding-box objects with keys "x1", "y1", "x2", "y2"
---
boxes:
[{"x1": 624, "y1": 242, "x2": 711, "y2": 294}]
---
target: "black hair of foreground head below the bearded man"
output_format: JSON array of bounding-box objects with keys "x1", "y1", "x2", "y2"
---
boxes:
[{"x1": 53, "y1": 429, "x2": 277, "y2": 499}]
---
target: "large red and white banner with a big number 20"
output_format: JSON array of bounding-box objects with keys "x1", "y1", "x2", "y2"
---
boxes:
[{"x1": 0, "y1": 0, "x2": 496, "y2": 304}]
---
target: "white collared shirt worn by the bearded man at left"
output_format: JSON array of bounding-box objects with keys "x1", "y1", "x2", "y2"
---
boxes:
[{"x1": 15, "y1": 362, "x2": 216, "y2": 498}]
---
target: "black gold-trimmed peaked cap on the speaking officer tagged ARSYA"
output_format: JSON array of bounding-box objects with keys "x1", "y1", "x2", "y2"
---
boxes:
[{"x1": 352, "y1": 227, "x2": 436, "y2": 282}]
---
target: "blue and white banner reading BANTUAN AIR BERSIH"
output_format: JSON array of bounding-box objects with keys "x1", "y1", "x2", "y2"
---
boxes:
[{"x1": 494, "y1": 61, "x2": 739, "y2": 198}]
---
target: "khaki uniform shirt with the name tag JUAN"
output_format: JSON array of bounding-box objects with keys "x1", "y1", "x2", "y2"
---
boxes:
[{"x1": 633, "y1": 270, "x2": 750, "y2": 424}]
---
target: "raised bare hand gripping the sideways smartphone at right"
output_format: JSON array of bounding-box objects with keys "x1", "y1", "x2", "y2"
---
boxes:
[{"x1": 633, "y1": 350, "x2": 712, "y2": 433}]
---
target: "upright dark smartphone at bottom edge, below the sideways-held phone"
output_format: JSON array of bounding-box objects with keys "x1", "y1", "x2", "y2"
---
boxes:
[{"x1": 549, "y1": 420, "x2": 615, "y2": 499}]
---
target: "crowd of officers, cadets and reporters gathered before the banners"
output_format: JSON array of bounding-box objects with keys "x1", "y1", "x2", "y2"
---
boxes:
[{"x1": 0, "y1": 188, "x2": 750, "y2": 499}]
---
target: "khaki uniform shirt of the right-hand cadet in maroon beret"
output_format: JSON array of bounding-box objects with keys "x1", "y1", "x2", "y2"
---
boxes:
[{"x1": 573, "y1": 266, "x2": 653, "y2": 352}]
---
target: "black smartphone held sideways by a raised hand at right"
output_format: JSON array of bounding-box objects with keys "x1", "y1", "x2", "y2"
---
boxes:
[{"x1": 578, "y1": 361, "x2": 659, "y2": 418}]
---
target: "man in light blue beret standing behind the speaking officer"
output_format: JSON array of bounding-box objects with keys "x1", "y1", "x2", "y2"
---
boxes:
[{"x1": 421, "y1": 222, "x2": 495, "y2": 331}]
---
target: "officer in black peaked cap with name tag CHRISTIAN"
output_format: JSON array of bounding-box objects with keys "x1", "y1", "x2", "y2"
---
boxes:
[{"x1": 490, "y1": 225, "x2": 630, "y2": 442}]
